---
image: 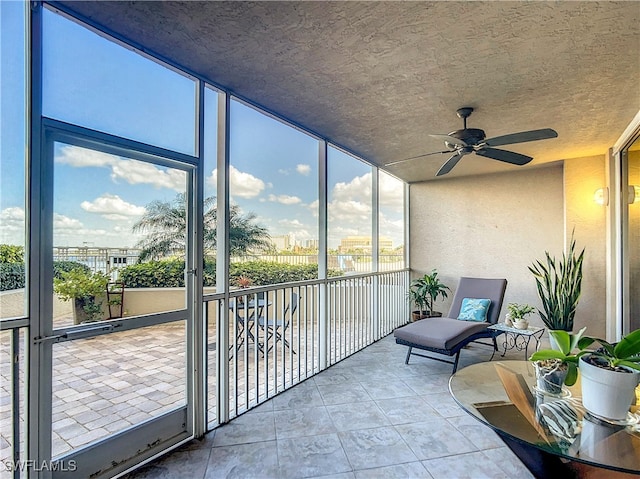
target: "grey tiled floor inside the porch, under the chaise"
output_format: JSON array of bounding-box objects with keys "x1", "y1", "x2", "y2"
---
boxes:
[{"x1": 120, "y1": 335, "x2": 533, "y2": 479}]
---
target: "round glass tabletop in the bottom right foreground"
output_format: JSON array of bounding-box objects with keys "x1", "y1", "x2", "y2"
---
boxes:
[{"x1": 449, "y1": 361, "x2": 640, "y2": 478}]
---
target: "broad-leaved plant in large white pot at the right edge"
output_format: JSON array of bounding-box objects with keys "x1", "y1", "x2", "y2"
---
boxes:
[{"x1": 579, "y1": 329, "x2": 640, "y2": 421}]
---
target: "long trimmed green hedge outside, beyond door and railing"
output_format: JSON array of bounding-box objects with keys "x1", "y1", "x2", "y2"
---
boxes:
[{"x1": 120, "y1": 259, "x2": 342, "y2": 288}]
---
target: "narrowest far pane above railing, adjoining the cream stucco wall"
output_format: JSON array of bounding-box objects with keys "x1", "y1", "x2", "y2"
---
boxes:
[{"x1": 378, "y1": 170, "x2": 405, "y2": 271}]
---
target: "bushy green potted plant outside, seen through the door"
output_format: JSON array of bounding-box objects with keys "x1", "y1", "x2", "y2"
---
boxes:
[{"x1": 53, "y1": 268, "x2": 109, "y2": 324}]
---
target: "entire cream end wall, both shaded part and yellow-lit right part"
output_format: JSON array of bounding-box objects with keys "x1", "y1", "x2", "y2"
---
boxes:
[{"x1": 410, "y1": 156, "x2": 606, "y2": 336}]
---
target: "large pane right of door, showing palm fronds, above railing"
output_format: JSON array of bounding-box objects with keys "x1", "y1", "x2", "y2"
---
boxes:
[{"x1": 229, "y1": 101, "x2": 318, "y2": 285}]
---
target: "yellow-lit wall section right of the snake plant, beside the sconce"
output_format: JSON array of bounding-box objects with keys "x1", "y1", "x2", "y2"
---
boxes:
[{"x1": 564, "y1": 156, "x2": 607, "y2": 337}]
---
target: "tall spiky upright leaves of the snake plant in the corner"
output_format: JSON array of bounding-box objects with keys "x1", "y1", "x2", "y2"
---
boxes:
[{"x1": 529, "y1": 234, "x2": 584, "y2": 331}]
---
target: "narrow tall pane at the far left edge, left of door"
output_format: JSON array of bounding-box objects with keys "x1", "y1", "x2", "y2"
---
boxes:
[{"x1": 0, "y1": 2, "x2": 29, "y2": 319}]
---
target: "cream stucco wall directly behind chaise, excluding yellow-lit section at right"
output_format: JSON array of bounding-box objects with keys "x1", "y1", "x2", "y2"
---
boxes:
[{"x1": 410, "y1": 165, "x2": 564, "y2": 325}]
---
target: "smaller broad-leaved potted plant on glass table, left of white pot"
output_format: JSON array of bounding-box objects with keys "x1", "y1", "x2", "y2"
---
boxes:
[{"x1": 529, "y1": 328, "x2": 587, "y2": 395}]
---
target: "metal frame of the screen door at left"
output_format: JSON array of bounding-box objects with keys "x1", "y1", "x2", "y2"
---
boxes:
[{"x1": 27, "y1": 118, "x2": 202, "y2": 478}]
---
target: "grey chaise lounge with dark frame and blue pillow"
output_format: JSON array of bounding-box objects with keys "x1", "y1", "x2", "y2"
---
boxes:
[{"x1": 393, "y1": 277, "x2": 507, "y2": 374}]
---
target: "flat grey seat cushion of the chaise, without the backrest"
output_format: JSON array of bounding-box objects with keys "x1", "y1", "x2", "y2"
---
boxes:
[{"x1": 393, "y1": 318, "x2": 489, "y2": 349}]
